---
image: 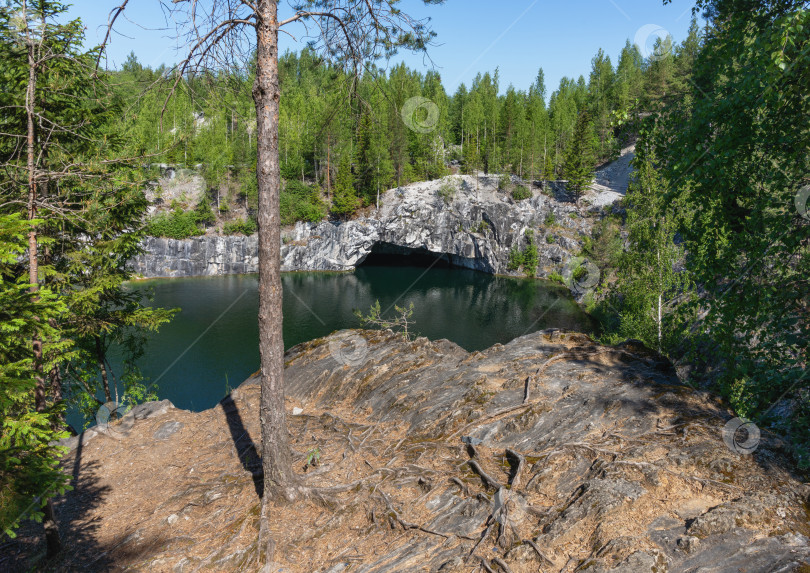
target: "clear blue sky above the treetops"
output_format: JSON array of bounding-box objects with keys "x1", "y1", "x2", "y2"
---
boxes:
[{"x1": 63, "y1": 0, "x2": 694, "y2": 95}]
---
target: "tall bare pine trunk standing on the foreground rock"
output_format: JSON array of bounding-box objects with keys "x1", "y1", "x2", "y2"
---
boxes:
[{"x1": 253, "y1": 0, "x2": 295, "y2": 562}]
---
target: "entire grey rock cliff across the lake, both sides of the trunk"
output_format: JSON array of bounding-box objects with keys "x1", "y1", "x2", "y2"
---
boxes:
[{"x1": 133, "y1": 176, "x2": 591, "y2": 278}]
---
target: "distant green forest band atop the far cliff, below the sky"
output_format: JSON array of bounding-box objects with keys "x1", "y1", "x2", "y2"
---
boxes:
[{"x1": 109, "y1": 20, "x2": 699, "y2": 230}]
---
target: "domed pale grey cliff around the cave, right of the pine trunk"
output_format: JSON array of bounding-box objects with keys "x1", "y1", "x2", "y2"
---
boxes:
[{"x1": 282, "y1": 176, "x2": 590, "y2": 276}]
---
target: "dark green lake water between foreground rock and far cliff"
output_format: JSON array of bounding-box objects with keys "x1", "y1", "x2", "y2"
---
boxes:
[{"x1": 82, "y1": 266, "x2": 592, "y2": 422}]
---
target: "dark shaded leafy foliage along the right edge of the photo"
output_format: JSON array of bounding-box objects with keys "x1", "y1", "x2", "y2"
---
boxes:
[{"x1": 648, "y1": 0, "x2": 810, "y2": 467}]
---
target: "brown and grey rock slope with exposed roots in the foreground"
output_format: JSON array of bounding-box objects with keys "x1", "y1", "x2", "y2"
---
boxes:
[{"x1": 17, "y1": 331, "x2": 810, "y2": 573}]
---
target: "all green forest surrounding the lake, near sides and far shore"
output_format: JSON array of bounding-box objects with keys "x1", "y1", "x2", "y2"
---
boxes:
[{"x1": 0, "y1": 0, "x2": 810, "y2": 560}]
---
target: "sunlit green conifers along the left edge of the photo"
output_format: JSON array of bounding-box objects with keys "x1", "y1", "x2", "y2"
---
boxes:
[{"x1": 0, "y1": 0, "x2": 178, "y2": 535}]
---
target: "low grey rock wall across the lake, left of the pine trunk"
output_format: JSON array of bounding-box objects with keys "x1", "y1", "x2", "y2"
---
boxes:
[{"x1": 131, "y1": 235, "x2": 259, "y2": 278}]
